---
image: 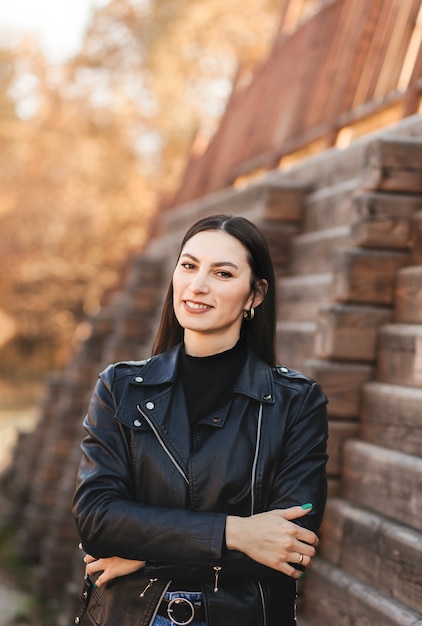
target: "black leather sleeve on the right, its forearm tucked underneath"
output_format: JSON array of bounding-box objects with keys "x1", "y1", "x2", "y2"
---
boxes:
[{"x1": 147, "y1": 382, "x2": 328, "y2": 583}]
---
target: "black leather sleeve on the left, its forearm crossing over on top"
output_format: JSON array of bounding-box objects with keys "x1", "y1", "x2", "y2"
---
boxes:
[{"x1": 73, "y1": 368, "x2": 226, "y2": 569}]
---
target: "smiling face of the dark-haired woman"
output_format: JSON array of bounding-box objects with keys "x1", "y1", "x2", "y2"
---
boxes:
[{"x1": 173, "y1": 230, "x2": 262, "y2": 356}]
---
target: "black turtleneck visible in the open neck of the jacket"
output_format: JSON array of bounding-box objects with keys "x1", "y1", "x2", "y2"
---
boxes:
[{"x1": 179, "y1": 340, "x2": 247, "y2": 427}]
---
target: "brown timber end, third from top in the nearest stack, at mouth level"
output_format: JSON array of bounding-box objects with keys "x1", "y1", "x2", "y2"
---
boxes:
[{"x1": 332, "y1": 248, "x2": 409, "y2": 304}]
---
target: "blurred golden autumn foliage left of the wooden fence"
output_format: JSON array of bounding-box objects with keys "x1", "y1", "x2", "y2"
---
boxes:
[{"x1": 0, "y1": 0, "x2": 280, "y2": 375}]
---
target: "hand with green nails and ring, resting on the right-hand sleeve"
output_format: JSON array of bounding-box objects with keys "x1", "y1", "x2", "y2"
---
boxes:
[{"x1": 226, "y1": 506, "x2": 319, "y2": 578}]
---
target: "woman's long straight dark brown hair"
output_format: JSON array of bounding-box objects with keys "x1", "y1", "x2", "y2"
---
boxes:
[{"x1": 152, "y1": 215, "x2": 276, "y2": 365}]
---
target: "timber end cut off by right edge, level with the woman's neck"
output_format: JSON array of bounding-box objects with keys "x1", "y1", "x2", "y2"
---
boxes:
[{"x1": 377, "y1": 324, "x2": 422, "y2": 387}]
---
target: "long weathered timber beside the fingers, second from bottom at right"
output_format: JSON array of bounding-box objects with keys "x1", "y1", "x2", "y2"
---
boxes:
[{"x1": 319, "y1": 498, "x2": 422, "y2": 614}]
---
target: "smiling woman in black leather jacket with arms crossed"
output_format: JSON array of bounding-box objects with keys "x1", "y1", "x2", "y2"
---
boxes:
[{"x1": 73, "y1": 215, "x2": 327, "y2": 626}]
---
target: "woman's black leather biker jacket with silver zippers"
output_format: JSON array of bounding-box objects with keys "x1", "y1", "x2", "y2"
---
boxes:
[{"x1": 73, "y1": 346, "x2": 327, "y2": 626}]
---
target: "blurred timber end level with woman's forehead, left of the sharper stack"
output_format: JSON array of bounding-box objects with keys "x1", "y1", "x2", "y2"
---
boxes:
[{"x1": 289, "y1": 226, "x2": 351, "y2": 274}]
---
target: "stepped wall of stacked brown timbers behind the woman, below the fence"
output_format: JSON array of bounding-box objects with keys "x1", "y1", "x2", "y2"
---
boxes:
[{"x1": 3, "y1": 116, "x2": 422, "y2": 626}]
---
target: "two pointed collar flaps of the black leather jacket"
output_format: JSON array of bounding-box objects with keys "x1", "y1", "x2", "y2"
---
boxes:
[{"x1": 131, "y1": 344, "x2": 274, "y2": 403}]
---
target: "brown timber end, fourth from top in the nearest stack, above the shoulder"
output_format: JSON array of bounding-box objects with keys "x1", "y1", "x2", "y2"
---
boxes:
[{"x1": 315, "y1": 304, "x2": 392, "y2": 361}]
